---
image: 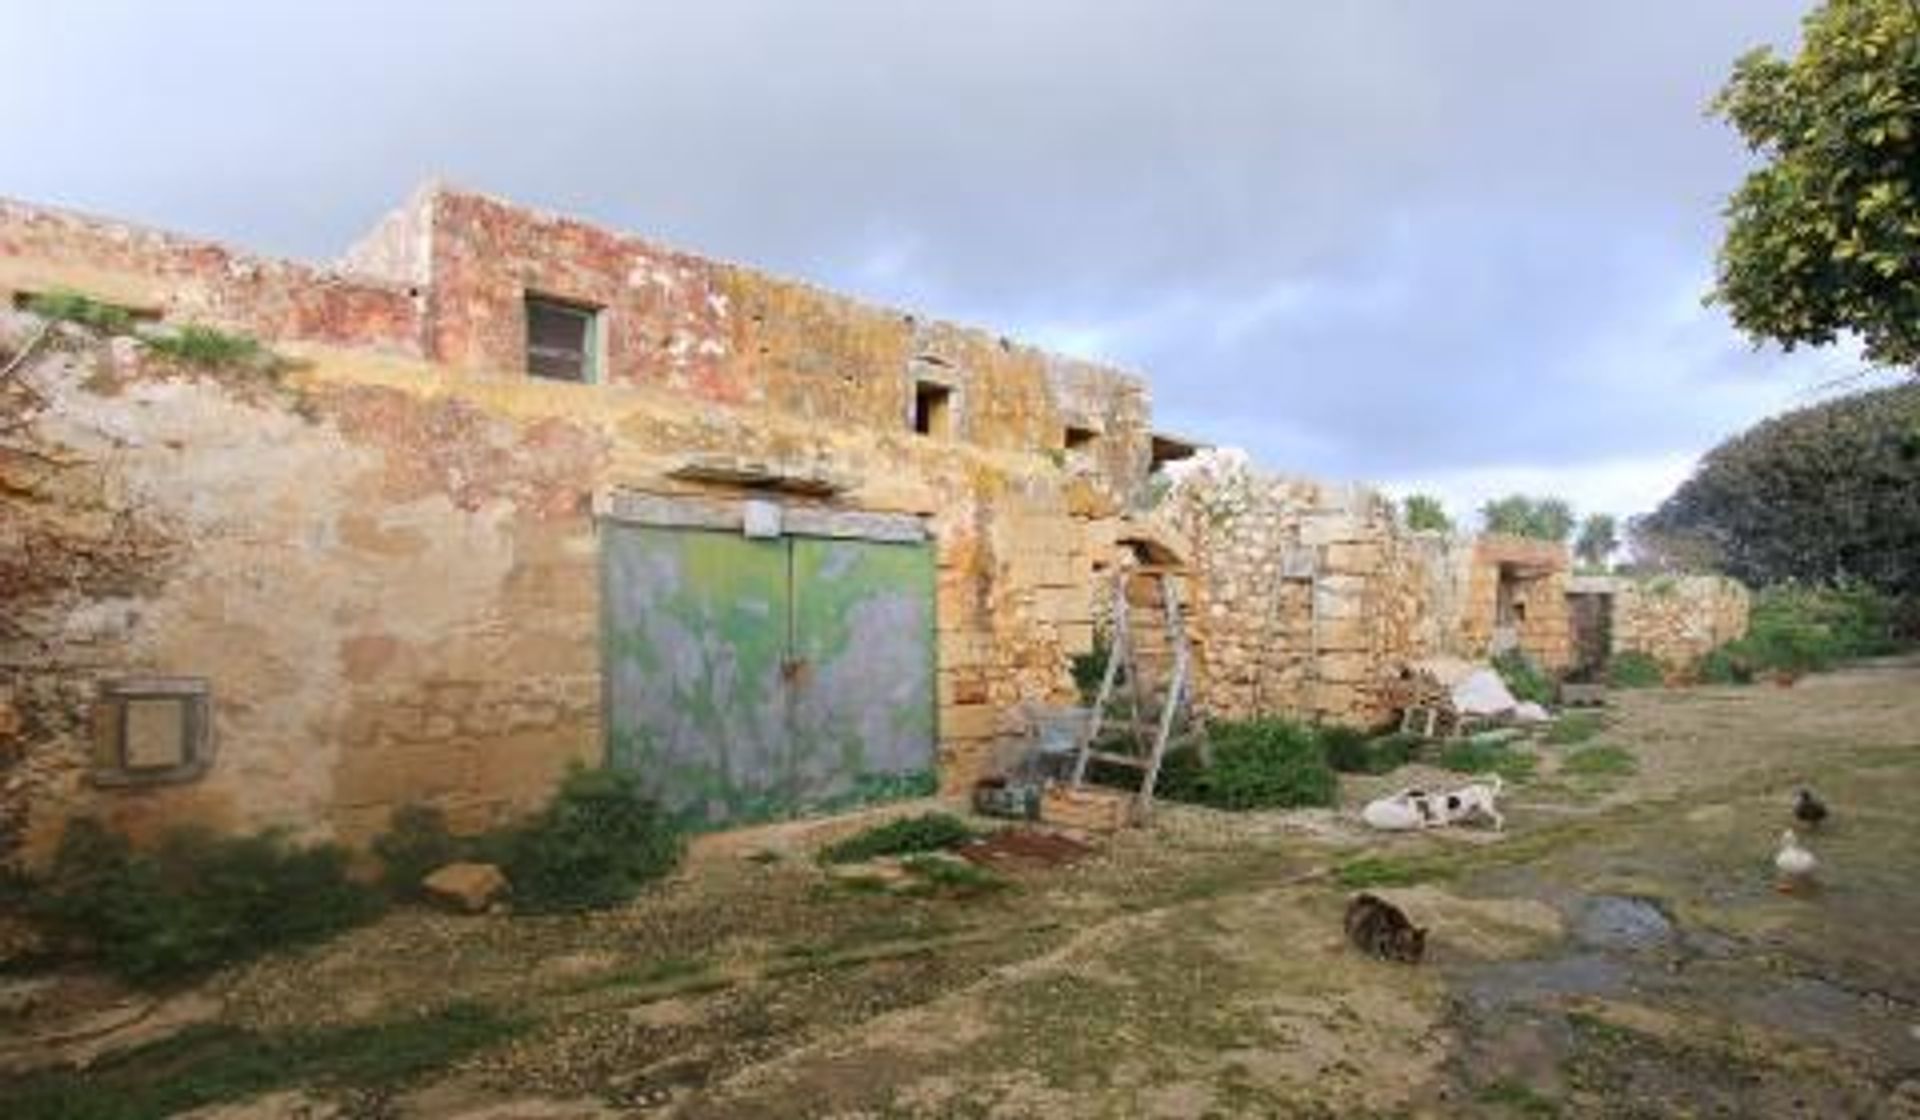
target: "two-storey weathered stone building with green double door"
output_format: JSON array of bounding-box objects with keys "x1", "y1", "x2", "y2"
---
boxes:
[{"x1": 0, "y1": 186, "x2": 1156, "y2": 855}]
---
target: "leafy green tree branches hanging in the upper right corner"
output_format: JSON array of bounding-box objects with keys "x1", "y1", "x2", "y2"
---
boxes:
[{"x1": 1711, "y1": 0, "x2": 1920, "y2": 371}]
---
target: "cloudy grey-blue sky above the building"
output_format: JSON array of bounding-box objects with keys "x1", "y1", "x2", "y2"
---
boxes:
[{"x1": 0, "y1": 0, "x2": 1889, "y2": 515}]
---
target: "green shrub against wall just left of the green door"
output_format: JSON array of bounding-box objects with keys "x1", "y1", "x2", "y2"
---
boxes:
[{"x1": 499, "y1": 767, "x2": 684, "y2": 913}]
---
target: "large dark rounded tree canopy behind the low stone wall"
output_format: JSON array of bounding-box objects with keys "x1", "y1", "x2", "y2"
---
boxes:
[{"x1": 1634, "y1": 384, "x2": 1920, "y2": 594}]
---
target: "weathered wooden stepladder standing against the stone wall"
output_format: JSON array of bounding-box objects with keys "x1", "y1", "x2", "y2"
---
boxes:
[{"x1": 1073, "y1": 565, "x2": 1206, "y2": 820}]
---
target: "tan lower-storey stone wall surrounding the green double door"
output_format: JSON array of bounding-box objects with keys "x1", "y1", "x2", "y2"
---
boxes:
[{"x1": 0, "y1": 321, "x2": 1114, "y2": 857}]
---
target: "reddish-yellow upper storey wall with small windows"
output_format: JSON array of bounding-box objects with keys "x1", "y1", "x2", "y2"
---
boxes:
[{"x1": 348, "y1": 188, "x2": 1150, "y2": 488}]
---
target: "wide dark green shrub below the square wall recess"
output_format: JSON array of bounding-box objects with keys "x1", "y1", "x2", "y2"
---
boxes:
[{"x1": 31, "y1": 818, "x2": 380, "y2": 982}]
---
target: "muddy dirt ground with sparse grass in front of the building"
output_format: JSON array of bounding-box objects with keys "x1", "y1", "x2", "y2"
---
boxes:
[{"x1": 0, "y1": 661, "x2": 1920, "y2": 1120}]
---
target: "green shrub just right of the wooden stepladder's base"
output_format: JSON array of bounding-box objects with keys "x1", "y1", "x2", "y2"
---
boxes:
[{"x1": 1158, "y1": 718, "x2": 1338, "y2": 809}]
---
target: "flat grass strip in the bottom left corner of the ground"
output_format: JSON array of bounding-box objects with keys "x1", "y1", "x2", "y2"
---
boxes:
[{"x1": 8, "y1": 1003, "x2": 526, "y2": 1120}]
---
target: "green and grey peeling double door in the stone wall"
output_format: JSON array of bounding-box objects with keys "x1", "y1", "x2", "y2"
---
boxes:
[{"x1": 603, "y1": 524, "x2": 935, "y2": 828}]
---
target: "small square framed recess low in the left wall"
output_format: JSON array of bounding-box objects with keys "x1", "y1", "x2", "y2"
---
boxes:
[{"x1": 92, "y1": 676, "x2": 213, "y2": 786}]
